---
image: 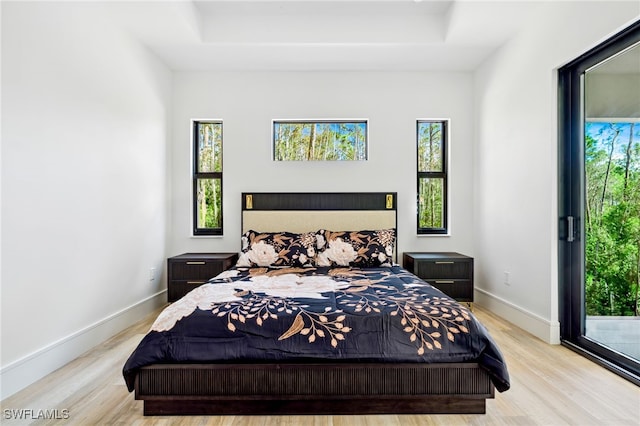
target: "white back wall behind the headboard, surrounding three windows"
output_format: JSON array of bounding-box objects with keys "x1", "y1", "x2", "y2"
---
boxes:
[{"x1": 169, "y1": 72, "x2": 473, "y2": 255}]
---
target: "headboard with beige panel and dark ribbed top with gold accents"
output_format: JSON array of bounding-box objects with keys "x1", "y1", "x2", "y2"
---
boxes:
[{"x1": 242, "y1": 192, "x2": 397, "y2": 260}]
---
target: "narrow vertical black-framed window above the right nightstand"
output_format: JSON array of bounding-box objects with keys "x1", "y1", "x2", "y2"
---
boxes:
[{"x1": 417, "y1": 120, "x2": 448, "y2": 234}]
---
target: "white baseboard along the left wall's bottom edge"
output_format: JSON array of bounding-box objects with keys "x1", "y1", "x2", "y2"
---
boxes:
[{"x1": 0, "y1": 290, "x2": 166, "y2": 400}]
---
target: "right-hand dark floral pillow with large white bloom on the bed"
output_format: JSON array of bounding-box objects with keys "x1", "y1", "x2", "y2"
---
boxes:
[{"x1": 316, "y1": 229, "x2": 396, "y2": 268}]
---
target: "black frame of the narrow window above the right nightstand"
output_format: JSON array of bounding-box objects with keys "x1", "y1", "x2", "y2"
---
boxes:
[{"x1": 416, "y1": 118, "x2": 449, "y2": 236}]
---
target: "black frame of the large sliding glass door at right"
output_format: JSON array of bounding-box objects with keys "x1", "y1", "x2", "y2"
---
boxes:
[{"x1": 558, "y1": 21, "x2": 640, "y2": 385}]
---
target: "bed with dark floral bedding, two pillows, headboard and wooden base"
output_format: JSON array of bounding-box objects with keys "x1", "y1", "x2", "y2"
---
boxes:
[{"x1": 123, "y1": 193, "x2": 509, "y2": 415}]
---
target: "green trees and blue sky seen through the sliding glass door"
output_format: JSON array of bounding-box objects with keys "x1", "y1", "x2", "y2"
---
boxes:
[{"x1": 584, "y1": 122, "x2": 640, "y2": 316}]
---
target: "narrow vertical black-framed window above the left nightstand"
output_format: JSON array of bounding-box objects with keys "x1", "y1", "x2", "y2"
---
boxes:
[{"x1": 193, "y1": 121, "x2": 222, "y2": 235}]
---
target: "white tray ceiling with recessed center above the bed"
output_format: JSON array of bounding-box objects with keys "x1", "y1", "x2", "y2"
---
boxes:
[{"x1": 108, "y1": 0, "x2": 540, "y2": 71}]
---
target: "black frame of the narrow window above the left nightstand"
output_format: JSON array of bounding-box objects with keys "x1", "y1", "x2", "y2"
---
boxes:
[{"x1": 191, "y1": 119, "x2": 224, "y2": 237}]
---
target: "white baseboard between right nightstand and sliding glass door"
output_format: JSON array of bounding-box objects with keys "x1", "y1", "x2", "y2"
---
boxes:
[{"x1": 474, "y1": 287, "x2": 560, "y2": 345}]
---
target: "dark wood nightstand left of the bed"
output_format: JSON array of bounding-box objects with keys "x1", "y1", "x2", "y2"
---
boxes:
[{"x1": 167, "y1": 253, "x2": 238, "y2": 302}]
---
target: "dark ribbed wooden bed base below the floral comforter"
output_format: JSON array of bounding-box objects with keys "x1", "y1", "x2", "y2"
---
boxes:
[{"x1": 135, "y1": 363, "x2": 494, "y2": 416}]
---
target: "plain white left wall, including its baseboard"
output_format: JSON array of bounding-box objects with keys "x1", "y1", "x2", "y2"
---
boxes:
[{"x1": 1, "y1": 2, "x2": 171, "y2": 398}]
